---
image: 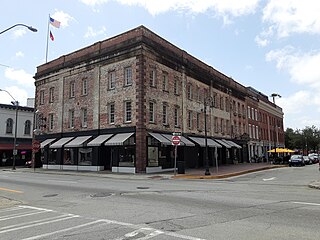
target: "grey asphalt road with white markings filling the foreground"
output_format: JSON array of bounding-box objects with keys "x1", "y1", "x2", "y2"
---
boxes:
[{"x1": 0, "y1": 165, "x2": 320, "y2": 240}]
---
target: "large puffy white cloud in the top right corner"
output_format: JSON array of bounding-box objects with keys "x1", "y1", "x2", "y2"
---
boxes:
[{"x1": 262, "y1": 0, "x2": 320, "y2": 37}]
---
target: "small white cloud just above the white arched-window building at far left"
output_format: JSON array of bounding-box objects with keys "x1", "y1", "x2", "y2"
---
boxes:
[{"x1": 0, "y1": 86, "x2": 30, "y2": 106}]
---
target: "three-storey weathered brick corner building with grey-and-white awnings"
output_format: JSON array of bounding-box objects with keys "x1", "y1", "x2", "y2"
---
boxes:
[{"x1": 34, "y1": 26, "x2": 284, "y2": 173}]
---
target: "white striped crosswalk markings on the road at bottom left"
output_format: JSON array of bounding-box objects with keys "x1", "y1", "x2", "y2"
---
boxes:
[{"x1": 0, "y1": 205, "x2": 205, "y2": 240}]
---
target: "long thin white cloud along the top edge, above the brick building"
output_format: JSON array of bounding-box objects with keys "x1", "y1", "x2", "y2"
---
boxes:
[{"x1": 80, "y1": 0, "x2": 259, "y2": 23}]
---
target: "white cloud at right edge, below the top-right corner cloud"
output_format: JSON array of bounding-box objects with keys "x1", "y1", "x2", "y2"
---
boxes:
[{"x1": 266, "y1": 46, "x2": 320, "y2": 89}]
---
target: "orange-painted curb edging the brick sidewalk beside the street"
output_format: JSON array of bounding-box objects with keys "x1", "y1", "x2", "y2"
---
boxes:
[{"x1": 172, "y1": 165, "x2": 287, "y2": 179}]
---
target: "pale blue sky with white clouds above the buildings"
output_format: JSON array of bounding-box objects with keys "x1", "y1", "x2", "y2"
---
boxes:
[{"x1": 0, "y1": 0, "x2": 320, "y2": 129}]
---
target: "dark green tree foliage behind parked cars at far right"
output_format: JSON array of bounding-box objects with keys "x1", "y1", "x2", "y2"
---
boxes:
[{"x1": 285, "y1": 126, "x2": 320, "y2": 152}]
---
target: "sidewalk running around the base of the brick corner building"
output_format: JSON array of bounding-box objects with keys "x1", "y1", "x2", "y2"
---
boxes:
[{"x1": 0, "y1": 163, "x2": 286, "y2": 179}]
